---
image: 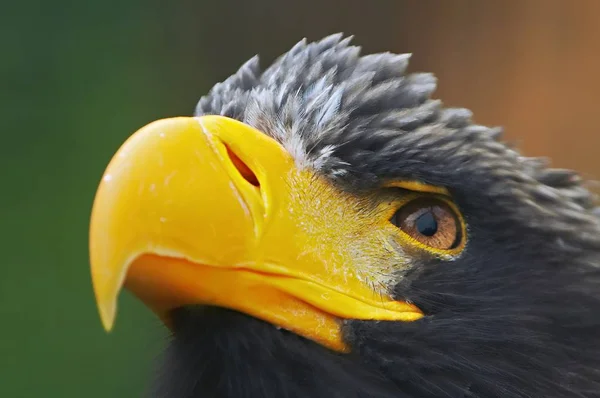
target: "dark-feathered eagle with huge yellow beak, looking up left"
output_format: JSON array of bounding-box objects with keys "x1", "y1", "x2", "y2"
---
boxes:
[{"x1": 90, "y1": 34, "x2": 600, "y2": 398}]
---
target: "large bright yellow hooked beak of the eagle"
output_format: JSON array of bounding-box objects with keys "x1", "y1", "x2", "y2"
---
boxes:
[{"x1": 90, "y1": 116, "x2": 422, "y2": 351}]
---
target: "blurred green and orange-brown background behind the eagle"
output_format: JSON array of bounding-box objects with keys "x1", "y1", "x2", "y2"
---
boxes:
[{"x1": 0, "y1": 0, "x2": 600, "y2": 398}]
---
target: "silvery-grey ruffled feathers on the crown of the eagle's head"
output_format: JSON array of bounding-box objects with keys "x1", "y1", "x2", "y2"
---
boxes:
[{"x1": 195, "y1": 34, "x2": 596, "y2": 236}]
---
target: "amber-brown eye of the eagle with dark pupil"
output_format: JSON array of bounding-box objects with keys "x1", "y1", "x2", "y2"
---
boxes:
[{"x1": 391, "y1": 198, "x2": 462, "y2": 250}]
